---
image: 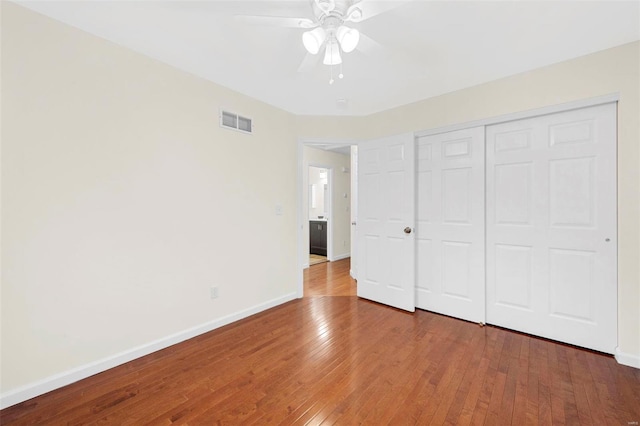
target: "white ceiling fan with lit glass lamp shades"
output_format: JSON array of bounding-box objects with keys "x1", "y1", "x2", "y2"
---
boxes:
[{"x1": 236, "y1": 0, "x2": 406, "y2": 84}]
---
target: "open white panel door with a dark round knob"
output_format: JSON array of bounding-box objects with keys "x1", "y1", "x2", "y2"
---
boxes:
[{"x1": 356, "y1": 133, "x2": 415, "y2": 312}]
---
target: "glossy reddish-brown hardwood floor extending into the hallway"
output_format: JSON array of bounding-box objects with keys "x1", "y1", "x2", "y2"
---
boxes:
[{"x1": 0, "y1": 259, "x2": 640, "y2": 426}]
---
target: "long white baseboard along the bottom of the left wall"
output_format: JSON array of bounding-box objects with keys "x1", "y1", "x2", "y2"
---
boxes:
[{"x1": 0, "y1": 293, "x2": 297, "y2": 409}]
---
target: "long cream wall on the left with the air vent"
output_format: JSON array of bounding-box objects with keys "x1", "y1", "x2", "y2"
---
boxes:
[{"x1": 0, "y1": 2, "x2": 297, "y2": 401}]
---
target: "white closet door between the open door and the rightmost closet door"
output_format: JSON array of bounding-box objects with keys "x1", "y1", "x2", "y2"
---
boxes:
[{"x1": 416, "y1": 127, "x2": 485, "y2": 322}]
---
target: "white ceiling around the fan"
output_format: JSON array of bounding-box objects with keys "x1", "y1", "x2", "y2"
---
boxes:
[{"x1": 12, "y1": 0, "x2": 640, "y2": 115}]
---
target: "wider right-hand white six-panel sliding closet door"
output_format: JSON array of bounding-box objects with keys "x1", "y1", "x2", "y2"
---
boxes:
[{"x1": 487, "y1": 104, "x2": 617, "y2": 353}]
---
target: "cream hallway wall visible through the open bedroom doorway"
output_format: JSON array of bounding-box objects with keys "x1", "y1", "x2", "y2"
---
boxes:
[{"x1": 302, "y1": 146, "x2": 351, "y2": 264}]
